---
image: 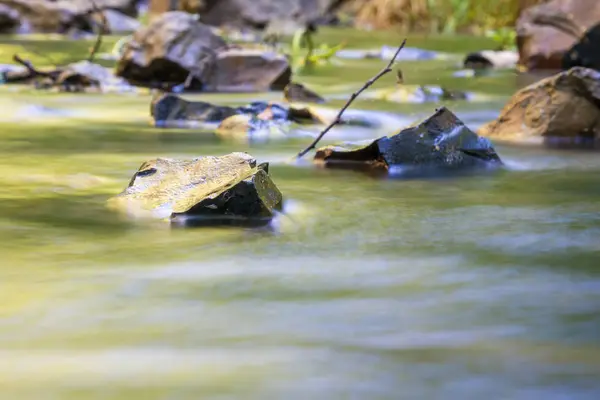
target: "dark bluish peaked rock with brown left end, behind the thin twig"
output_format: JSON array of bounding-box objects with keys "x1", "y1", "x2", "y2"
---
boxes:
[{"x1": 314, "y1": 107, "x2": 502, "y2": 172}]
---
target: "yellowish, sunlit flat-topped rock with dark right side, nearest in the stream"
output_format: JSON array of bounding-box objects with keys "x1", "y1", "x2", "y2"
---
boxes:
[{"x1": 108, "y1": 153, "x2": 283, "y2": 226}]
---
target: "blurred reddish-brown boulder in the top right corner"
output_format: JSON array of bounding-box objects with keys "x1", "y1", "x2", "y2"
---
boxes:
[{"x1": 516, "y1": 0, "x2": 600, "y2": 70}]
